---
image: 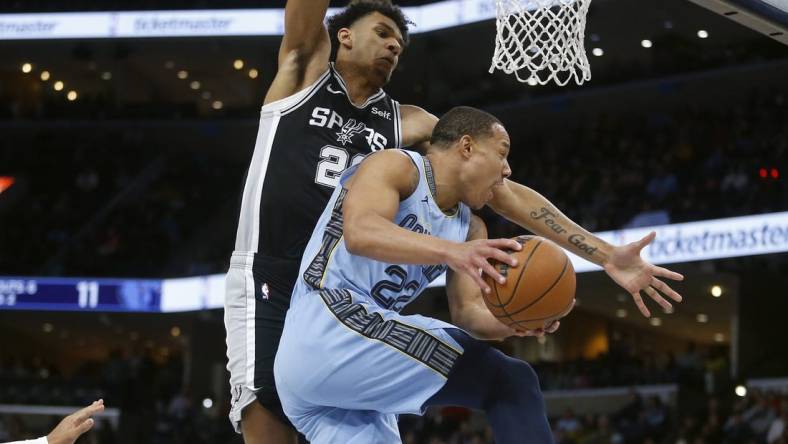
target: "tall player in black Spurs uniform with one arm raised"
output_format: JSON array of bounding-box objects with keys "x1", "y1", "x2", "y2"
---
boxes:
[{"x1": 225, "y1": 0, "x2": 681, "y2": 444}]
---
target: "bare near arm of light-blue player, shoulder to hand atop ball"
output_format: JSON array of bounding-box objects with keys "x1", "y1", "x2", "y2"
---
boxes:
[{"x1": 342, "y1": 150, "x2": 521, "y2": 292}]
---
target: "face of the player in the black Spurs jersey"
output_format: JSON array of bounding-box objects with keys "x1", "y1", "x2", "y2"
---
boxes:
[{"x1": 350, "y1": 12, "x2": 404, "y2": 84}]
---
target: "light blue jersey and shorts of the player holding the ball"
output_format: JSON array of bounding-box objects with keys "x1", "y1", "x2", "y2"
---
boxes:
[{"x1": 274, "y1": 150, "x2": 471, "y2": 444}]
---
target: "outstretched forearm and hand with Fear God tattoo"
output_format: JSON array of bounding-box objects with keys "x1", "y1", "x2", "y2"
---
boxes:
[{"x1": 489, "y1": 180, "x2": 684, "y2": 317}]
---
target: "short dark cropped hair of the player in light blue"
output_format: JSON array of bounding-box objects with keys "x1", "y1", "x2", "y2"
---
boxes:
[{"x1": 430, "y1": 106, "x2": 503, "y2": 148}]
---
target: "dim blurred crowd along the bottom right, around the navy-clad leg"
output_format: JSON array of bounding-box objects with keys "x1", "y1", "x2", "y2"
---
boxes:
[{"x1": 400, "y1": 390, "x2": 788, "y2": 444}]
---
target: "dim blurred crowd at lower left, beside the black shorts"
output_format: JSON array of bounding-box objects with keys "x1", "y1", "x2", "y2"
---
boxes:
[{"x1": 0, "y1": 348, "x2": 241, "y2": 444}]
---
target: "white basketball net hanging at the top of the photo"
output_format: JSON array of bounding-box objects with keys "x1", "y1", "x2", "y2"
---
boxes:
[{"x1": 490, "y1": 0, "x2": 591, "y2": 86}]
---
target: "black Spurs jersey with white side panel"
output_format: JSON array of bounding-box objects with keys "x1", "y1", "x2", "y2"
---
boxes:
[{"x1": 229, "y1": 64, "x2": 402, "y2": 293}]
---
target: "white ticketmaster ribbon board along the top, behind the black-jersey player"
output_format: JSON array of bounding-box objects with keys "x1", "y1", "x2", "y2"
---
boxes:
[{"x1": 0, "y1": 0, "x2": 495, "y2": 40}]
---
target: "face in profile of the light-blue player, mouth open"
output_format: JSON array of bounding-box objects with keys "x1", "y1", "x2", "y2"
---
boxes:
[{"x1": 464, "y1": 123, "x2": 512, "y2": 209}]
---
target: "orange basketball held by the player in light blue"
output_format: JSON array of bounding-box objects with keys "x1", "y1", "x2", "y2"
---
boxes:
[{"x1": 484, "y1": 236, "x2": 576, "y2": 330}]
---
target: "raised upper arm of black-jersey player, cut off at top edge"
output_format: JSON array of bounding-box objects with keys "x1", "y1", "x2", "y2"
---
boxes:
[{"x1": 264, "y1": 0, "x2": 331, "y2": 104}]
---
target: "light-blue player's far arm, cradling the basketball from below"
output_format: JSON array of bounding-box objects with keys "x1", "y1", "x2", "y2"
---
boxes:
[{"x1": 446, "y1": 216, "x2": 560, "y2": 341}]
